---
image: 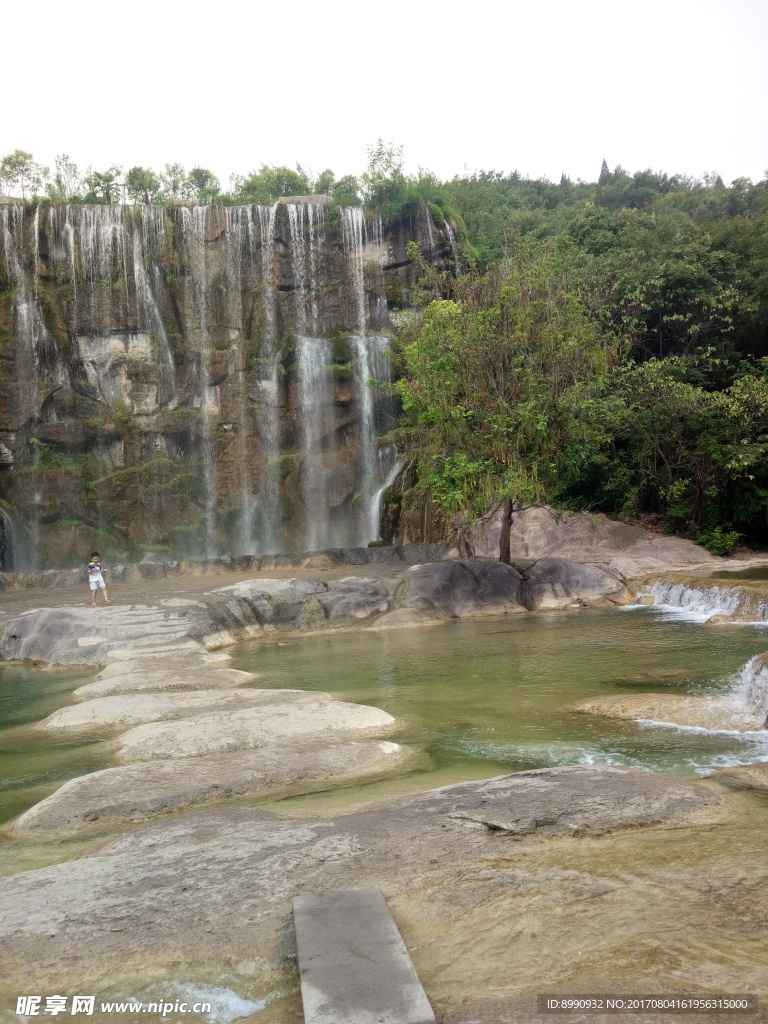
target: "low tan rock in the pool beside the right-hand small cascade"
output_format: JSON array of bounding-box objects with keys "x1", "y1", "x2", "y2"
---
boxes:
[{"x1": 572, "y1": 693, "x2": 762, "y2": 732}]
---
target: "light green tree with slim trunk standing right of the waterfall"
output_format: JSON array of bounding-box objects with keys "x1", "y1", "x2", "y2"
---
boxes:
[{"x1": 397, "y1": 244, "x2": 616, "y2": 562}]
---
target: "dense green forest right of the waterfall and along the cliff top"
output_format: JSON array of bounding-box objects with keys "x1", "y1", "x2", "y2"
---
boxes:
[{"x1": 0, "y1": 142, "x2": 768, "y2": 554}]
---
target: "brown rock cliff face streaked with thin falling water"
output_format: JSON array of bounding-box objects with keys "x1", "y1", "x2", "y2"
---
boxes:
[{"x1": 0, "y1": 196, "x2": 453, "y2": 569}]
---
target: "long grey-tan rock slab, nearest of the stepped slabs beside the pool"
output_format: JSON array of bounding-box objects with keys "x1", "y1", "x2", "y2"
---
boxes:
[{"x1": 12, "y1": 739, "x2": 417, "y2": 835}]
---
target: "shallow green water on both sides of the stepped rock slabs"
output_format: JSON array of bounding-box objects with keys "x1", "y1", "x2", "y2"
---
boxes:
[{"x1": 0, "y1": 608, "x2": 768, "y2": 822}]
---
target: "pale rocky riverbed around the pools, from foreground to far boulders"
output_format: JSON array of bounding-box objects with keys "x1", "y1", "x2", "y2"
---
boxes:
[{"x1": 0, "y1": 557, "x2": 768, "y2": 1024}]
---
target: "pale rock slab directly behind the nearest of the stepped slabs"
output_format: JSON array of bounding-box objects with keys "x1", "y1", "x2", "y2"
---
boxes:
[{"x1": 119, "y1": 690, "x2": 396, "y2": 761}]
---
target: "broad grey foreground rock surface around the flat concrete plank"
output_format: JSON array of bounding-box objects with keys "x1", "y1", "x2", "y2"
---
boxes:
[{"x1": 0, "y1": 768, "x2": 718, "y2": 997}]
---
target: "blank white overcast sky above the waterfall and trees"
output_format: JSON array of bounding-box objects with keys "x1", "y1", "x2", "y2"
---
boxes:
[{"x1": 6, "y1": 0, "x2": 768, "y2": 184}]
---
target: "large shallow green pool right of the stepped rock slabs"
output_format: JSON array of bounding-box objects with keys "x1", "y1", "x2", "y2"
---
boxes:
[{"x1": 234, "y1": 608, "x2": 768, "y2": 784}]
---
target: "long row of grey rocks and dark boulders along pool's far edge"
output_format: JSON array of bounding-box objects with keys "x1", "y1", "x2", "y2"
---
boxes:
[{"x1": 0, "y1": 549, "x2": 634, "y2": 667}]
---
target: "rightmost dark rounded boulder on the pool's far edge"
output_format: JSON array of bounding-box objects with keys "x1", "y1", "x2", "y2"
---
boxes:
[{"x1": 520, "y1": 558, "x2": 635, "y2": 611}]
